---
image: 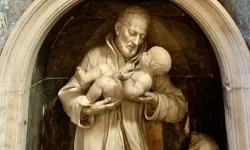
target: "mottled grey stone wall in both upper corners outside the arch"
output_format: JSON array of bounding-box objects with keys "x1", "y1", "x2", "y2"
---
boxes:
[{"x1": 0, "y1": 0, "x2": 250, "y2": 54}]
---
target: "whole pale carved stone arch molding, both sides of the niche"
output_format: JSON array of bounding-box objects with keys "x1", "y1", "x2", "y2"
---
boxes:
[{"x1": 0, "y1": 0, "x2": 250, "y2": 150}]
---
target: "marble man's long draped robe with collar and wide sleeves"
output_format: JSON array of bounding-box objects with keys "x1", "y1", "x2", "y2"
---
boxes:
[{"x1": 58, "y1": 34, "x2": 187, "y2": 150}]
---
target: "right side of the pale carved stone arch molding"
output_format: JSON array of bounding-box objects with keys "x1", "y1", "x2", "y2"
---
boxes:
[{"x1": 172, "y1": 0, "x2": 250, "y2": 150}]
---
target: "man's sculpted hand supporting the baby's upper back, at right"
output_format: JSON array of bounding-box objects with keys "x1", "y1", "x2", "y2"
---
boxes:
[{"x1": 135, "y1": 92, "x2": 159, "y2": 109}]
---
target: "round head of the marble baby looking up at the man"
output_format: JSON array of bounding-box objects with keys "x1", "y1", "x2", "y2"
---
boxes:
[{"x1": 139, "y1": 46, "x2": 172, "y2": 75}]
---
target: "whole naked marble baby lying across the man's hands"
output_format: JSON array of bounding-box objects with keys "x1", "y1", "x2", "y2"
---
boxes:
[{"x1": 76, "y1": 46, "x2": 171, "y2": 105}]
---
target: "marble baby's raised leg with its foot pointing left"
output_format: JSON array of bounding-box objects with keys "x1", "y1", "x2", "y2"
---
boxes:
[{"x1": 76, "y1": 64, "x2": 114, "y2": 85}]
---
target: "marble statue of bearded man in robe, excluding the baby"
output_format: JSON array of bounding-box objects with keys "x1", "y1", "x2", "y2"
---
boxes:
[{"x1": 58, "y1": 6, "x2": 186, "y2": 150}]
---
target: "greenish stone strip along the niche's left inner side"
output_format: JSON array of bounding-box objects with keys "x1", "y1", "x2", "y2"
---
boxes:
[{"x1": 26, "y1": 45, "x2": 47, "y2": 150}]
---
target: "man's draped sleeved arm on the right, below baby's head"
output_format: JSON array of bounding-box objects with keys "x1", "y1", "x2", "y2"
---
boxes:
[{"x1": 145, "y1": 75, "x2": 187, "y2": 123}]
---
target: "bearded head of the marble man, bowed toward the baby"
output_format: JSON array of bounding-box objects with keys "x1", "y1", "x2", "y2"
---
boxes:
[{"x1": 115, "y1": 6, "x2": 151, "y2": 58}]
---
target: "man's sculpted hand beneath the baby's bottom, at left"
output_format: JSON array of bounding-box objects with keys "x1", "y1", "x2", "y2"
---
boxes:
[{"x1": 82, "y1": 98, "x2": 121, "y2": 115}]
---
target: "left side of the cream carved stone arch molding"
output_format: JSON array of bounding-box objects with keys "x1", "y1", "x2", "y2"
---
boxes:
[{"x1": 0, "y1": 0, "x2": 79, "y2": 150}]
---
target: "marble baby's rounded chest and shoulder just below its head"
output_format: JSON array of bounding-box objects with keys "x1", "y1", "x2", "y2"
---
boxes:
[{"x1": 122, "y1": 73, "x2": 152, "y2": 99}]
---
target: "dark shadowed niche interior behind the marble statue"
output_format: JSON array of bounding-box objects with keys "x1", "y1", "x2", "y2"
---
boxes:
[{"x1": 26, "y1": 0, "x2": 227, "y2": 150}]
